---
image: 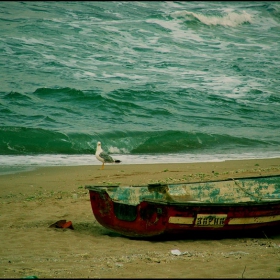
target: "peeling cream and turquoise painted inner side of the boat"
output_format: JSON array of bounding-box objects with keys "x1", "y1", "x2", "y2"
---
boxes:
[{"x1": 87, "y1": 177, "x2": 280, "y2": 205}]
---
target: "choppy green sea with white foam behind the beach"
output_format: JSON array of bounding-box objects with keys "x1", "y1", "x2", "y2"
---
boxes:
[{"x1": 0, "y1": 1, "x2": 280, "y2": 174}]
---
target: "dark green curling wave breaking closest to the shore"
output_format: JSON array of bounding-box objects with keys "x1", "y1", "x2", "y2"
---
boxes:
[{"x1": 0, "y1": 127, "x2": 277, "y2": 155}]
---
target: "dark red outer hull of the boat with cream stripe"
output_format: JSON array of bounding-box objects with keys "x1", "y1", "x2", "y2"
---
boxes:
[{"x1": 89, "y1": 187, "x2": 280, "y2": 237}]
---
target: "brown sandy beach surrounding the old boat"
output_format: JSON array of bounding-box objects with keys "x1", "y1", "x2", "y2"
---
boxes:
[{"x1": 0, "y1": 158, "x2": 280, "y2": 278}]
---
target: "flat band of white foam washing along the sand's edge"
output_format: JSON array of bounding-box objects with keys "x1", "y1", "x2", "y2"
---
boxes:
[{"x1": 0, "y1": 152, "x2": 280, "y2": 175}]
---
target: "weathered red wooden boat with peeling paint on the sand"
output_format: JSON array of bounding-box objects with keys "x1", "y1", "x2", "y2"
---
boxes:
[{"x1": 85, "y1": 175, "x2": 280, "y2": 237}]
